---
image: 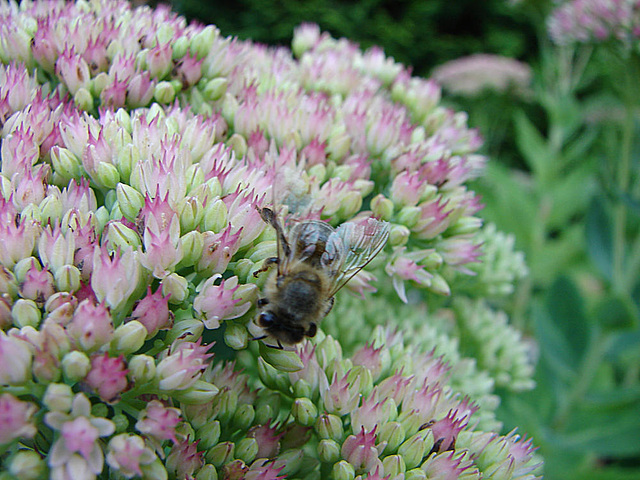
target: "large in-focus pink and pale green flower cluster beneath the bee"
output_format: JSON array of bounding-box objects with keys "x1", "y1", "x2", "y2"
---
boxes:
[{"x1": 0, "y1": 0, "x2": 535, "y2": 480}]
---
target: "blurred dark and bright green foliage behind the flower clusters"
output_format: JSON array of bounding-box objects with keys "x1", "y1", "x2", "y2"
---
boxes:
[{"x1": 152, "y1": 0, "x2": 640, "y2": 480}]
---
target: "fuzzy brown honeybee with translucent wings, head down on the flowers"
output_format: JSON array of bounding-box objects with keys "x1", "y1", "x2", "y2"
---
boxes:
[{"x1": 254, "y1": 207, "x2": 389, "y2": 348}]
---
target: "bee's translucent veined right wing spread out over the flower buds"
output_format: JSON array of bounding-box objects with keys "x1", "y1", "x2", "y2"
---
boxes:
[{"x1": 327, "y1": 218, "x2": 390, "y2": 296}]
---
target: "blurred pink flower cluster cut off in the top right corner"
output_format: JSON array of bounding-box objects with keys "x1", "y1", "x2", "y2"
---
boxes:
[{"x1": 547, "y1": 0, "x2": 640, "y2": 45}]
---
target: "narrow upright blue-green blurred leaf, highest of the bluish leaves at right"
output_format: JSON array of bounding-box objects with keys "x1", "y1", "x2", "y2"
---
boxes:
[{"x1": 586, "y1": 196, "x2": 613, "y2": 280}]
